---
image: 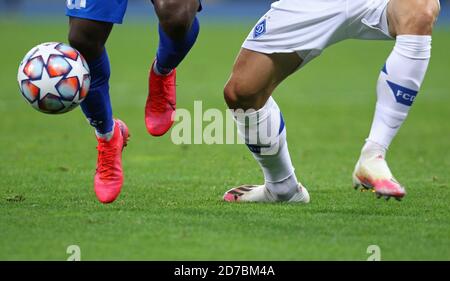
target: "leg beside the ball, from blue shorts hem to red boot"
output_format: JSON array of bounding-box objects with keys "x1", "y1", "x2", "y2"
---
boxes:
[{"x1": 67, "y1": 0, "x2": 128, "y2": 203}]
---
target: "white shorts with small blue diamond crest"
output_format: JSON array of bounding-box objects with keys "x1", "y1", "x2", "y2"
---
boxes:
[{"x1": 242, "y1": 0, "x2": 393, "y2": 66}]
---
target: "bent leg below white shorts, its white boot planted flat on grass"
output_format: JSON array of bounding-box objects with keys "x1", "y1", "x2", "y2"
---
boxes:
[{"x1": 224, "y1": 49, "x2": 309, "y2": 203}]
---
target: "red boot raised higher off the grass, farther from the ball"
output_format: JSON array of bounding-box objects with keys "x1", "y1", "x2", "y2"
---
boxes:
[{"x1": 145, "y1": 61, "x2": 176, "y2": 136}]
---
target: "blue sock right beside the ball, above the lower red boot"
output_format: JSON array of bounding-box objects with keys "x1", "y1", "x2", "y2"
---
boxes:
[{"x1": 81, "y1": 49, "x2": 114, "y2": 134}]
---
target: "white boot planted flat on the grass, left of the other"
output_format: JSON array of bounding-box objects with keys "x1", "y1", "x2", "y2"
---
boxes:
[{"x1": 223, "y1": 183, "x2": 310, "y2": 204}]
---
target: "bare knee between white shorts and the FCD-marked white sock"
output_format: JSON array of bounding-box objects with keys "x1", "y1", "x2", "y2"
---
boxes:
[{"x1": 397, "y1": 0, "x2": 439, "y2": 35}]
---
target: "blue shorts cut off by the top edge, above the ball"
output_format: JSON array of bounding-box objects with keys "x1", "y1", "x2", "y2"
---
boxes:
[{"x1": 66, "y1": 0, "x2": 202, "y2": 23}]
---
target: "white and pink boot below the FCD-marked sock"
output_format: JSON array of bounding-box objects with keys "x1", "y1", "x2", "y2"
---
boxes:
[{"x1": 353, "y1": 154, "x2": 406, "y2": 201}]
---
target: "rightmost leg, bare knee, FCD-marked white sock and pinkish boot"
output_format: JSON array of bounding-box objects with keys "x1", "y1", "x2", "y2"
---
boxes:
[{"x1": 354, "y1": 0, "x2": 439, "y2": 198}]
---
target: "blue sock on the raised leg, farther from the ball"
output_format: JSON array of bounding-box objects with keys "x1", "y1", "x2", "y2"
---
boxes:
[{"x1": 156, "y1": 17, "x2": 200, "y2": 74}]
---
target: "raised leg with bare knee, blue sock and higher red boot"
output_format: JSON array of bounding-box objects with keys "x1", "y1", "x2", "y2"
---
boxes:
[{"x1": 145, "y1": 0, "x2": 200, "y2": 136}]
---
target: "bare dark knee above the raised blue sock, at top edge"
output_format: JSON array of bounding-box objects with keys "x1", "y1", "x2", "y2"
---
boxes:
[{"x1": 154, "y1": 0, "x2": 198, "y2": 39}]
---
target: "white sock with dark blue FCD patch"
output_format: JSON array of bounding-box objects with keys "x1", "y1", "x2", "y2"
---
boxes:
[{"x1": 363, "y1": 35, "x2": 431, "y2": 153}]
